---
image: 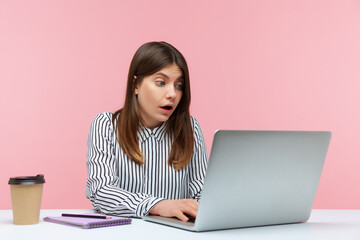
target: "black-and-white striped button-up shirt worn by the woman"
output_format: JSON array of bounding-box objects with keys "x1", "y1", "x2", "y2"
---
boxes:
[{"x1": 86, "y1": 113, "x2": 208, "y2": 217}]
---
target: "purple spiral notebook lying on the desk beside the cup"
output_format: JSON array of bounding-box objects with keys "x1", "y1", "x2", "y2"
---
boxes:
[{"x1": 44, "y1": 213, "x2": 131, "y2": 229}]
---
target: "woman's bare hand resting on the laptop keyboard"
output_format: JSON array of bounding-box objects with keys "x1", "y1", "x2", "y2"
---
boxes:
[{"x1": 150, "y1": 199, "x2": 199, "y2": 222}]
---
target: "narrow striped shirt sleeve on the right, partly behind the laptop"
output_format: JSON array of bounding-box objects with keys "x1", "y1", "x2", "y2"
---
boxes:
[{"x1": 189, "y1": 117, "x2": 208, "y2": 201}]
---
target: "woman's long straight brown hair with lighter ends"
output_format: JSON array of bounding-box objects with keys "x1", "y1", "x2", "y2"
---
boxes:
[{"x1": 112, "y1": 42, "x2": 194, "y2": 170}]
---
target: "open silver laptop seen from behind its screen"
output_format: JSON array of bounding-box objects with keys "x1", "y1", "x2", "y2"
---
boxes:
[{"x1": 144, "y1": 130, "x2": 331, "y2": 232}]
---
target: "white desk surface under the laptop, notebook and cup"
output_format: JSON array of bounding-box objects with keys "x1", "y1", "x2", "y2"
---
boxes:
[{"x1": 0, "y1": 210, "x2": 360, "y2": 240}]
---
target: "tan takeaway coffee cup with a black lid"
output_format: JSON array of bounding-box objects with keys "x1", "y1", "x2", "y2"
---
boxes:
[{"x1": 9, "y1": 174, "x2": 45, "y2": 225}]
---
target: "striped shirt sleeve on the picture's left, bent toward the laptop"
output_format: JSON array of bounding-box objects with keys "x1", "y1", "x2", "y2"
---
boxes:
[{"x1": 86, "y1": 113, "x2": 163, "y2": 217}]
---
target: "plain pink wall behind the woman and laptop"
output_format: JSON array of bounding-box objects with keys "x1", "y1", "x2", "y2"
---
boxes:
[{"x1": 0, "y1": 0, "x2": 360, "y2": 209}]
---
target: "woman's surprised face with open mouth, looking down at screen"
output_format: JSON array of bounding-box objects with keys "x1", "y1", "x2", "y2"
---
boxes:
[{"x1": 135, "y1": 64, "x2": 184, "y2": 129}]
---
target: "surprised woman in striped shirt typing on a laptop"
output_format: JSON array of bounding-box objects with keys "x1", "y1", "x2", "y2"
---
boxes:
[{"x1": 86, "y1": 42, "x2": 208, "y2": 221}]
